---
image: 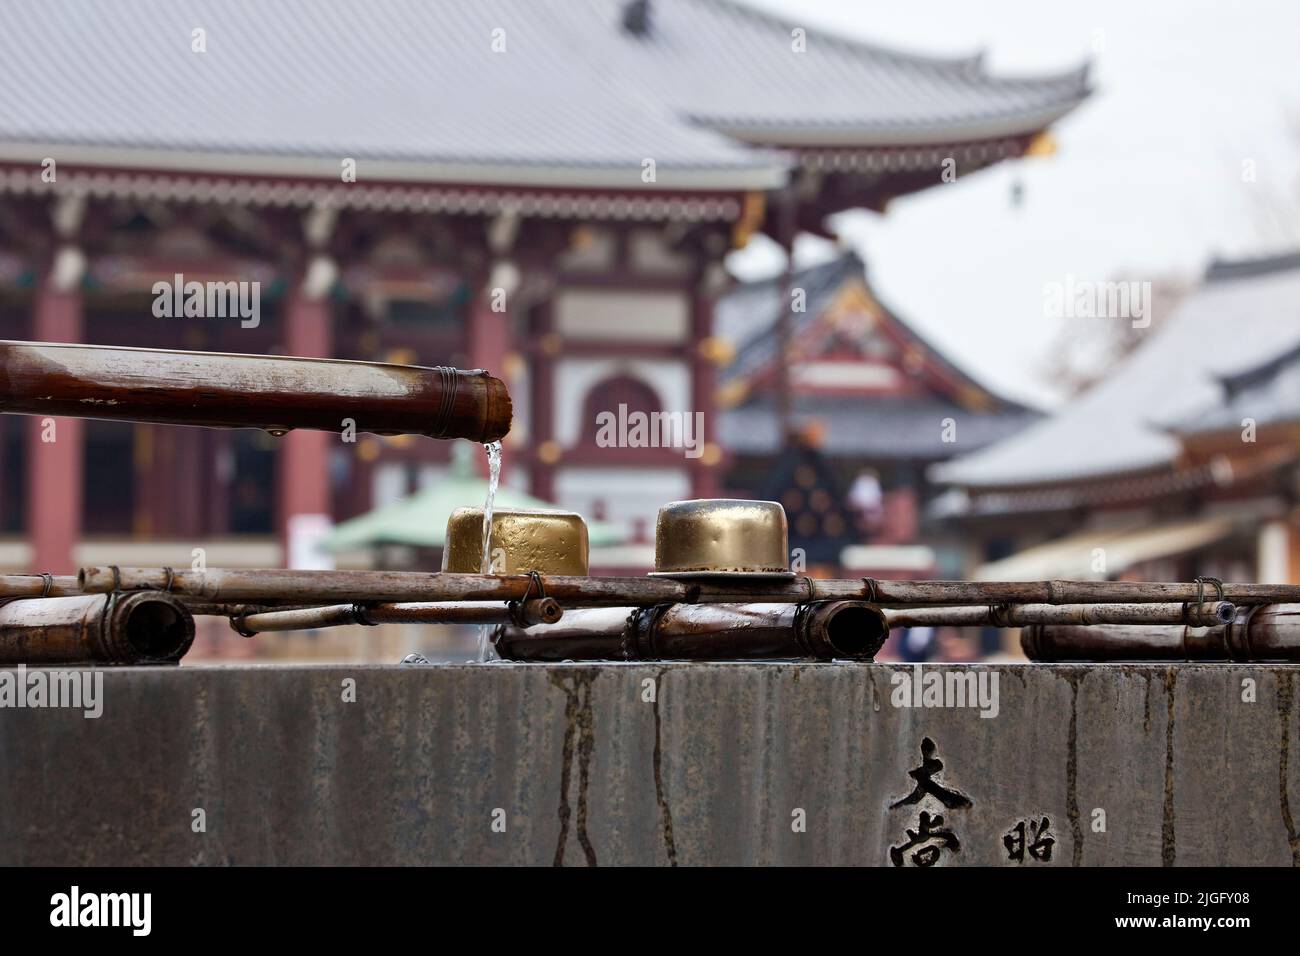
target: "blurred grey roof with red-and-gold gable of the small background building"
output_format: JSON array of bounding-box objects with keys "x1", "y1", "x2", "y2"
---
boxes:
[{"x1": 714, "y1": 252, "x2": 1039, "y2": 460}]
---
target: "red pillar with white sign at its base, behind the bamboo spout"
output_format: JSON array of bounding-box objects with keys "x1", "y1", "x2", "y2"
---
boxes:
[{"x1": 277, "y1": 289, "x2": 342, "y2": 567}]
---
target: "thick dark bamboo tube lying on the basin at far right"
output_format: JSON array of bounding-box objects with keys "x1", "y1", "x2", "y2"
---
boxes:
[{"x1": 1021, "y1": 604, "x2": 1300, "y2": 661}]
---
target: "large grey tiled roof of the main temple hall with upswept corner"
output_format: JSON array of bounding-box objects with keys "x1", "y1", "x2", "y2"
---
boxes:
[{"x1": 0, "y1": 0, "x2": 1087, "y2": 189}]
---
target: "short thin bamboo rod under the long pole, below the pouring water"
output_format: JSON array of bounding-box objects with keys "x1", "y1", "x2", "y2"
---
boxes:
[{"x1": 230, "y1": 597, "x2": 564, "y2": 637}]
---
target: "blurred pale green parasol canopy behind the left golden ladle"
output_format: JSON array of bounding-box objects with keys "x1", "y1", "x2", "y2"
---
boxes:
[{"x1": 321, "y1": 454, "x2": 628, "y2": 551}]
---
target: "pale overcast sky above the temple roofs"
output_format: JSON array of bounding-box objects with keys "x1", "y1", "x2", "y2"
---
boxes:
[{"x1": 732, "y1": 0, "x2": 1300, "y2": 405}]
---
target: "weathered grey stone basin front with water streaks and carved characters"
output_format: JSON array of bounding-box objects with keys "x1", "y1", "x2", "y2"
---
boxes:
[{"x1": 0, "y1": 663, "x2": 1300, "y2": 866}]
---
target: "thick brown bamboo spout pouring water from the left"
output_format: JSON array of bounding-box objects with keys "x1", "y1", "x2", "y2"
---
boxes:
[{"x1": 0, "y1": 341, "x2": 511, "y2": 442}]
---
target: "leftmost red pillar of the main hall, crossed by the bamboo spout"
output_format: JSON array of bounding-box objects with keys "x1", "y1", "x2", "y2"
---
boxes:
[{"x1": 26, "y1": 280, "x2": 85, "y2": 574}]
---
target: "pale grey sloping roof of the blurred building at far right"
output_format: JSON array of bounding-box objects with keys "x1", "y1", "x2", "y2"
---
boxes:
[{"x1": 931, "y1": 255, "x2": 1300, "y2": 488}]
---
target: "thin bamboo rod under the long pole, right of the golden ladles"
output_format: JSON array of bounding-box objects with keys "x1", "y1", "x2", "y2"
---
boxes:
[{"x1": 885, "y1": 601, "x2": 1236, "y2": 627}]
